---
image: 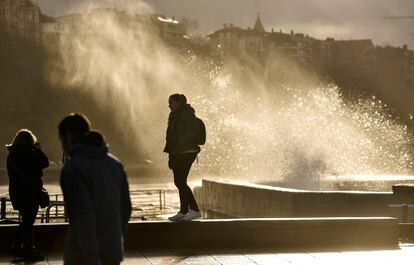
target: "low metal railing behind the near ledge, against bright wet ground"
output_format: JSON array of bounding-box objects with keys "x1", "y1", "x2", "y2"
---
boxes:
[{"x1": 0, "y1": 189, "x2": 176, "y2": 223}]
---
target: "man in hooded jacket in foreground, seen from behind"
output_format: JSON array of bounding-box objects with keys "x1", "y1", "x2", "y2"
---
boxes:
[{"x1": 59, "y1": 113, "x2": 131, "y2": 265}]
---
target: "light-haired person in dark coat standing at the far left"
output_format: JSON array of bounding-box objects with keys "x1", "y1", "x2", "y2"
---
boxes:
[{"x1": 6, "y1": 129, "x2": 49, "y2": 261}]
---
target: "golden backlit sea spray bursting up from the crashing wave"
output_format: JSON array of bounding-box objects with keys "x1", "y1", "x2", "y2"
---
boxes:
[{"x1": 42, "y1": 2, "x2": 412, "y2": 188}]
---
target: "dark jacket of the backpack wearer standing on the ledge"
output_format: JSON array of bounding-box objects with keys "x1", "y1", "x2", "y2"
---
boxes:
[{"x1": 164, "y1": 104, "x2": 200, "y2": 154}]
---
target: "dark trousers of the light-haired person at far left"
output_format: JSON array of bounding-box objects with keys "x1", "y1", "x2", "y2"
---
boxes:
[{"x1": 14, "y1": 205, "x2": 39, "y2": 252}]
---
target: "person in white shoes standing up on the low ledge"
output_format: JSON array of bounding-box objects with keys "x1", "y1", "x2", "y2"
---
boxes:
[{"x1": 164, "y1": 94, "x2": 201, "y2": 221}]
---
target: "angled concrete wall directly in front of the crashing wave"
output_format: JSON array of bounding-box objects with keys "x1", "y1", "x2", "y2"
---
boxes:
[{"x1": 194, "y1": 179, "x2": 397, "y2": 218}]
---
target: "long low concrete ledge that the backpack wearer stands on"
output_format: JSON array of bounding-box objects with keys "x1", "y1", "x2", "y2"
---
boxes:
[{"x1": 0, "y1": 218, "x2": 399, "y2": 252}]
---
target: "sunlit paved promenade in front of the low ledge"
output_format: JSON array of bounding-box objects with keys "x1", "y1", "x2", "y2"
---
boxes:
[{"x1": 0, "y1": 244, "x2": 414, "y2": 265}]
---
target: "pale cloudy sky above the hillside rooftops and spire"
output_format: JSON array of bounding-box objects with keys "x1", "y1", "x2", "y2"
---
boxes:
[{"x1": 35, "y1": 0, "x2": 414, "y2": 50}]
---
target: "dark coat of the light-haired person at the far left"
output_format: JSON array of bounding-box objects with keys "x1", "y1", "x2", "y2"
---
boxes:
[{"x1": 7, "y1": 145, "x2": 49, "y2": 210}]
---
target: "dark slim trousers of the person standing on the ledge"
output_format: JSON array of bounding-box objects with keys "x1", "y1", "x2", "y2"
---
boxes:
[{"x1": 169, "y1": 153, "x2": 199, "y2": 214}]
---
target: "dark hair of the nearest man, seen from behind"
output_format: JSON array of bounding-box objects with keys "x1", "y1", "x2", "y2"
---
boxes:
[{"x1": 59, "y1": 113, "x2": 91, "y2": 141}]
